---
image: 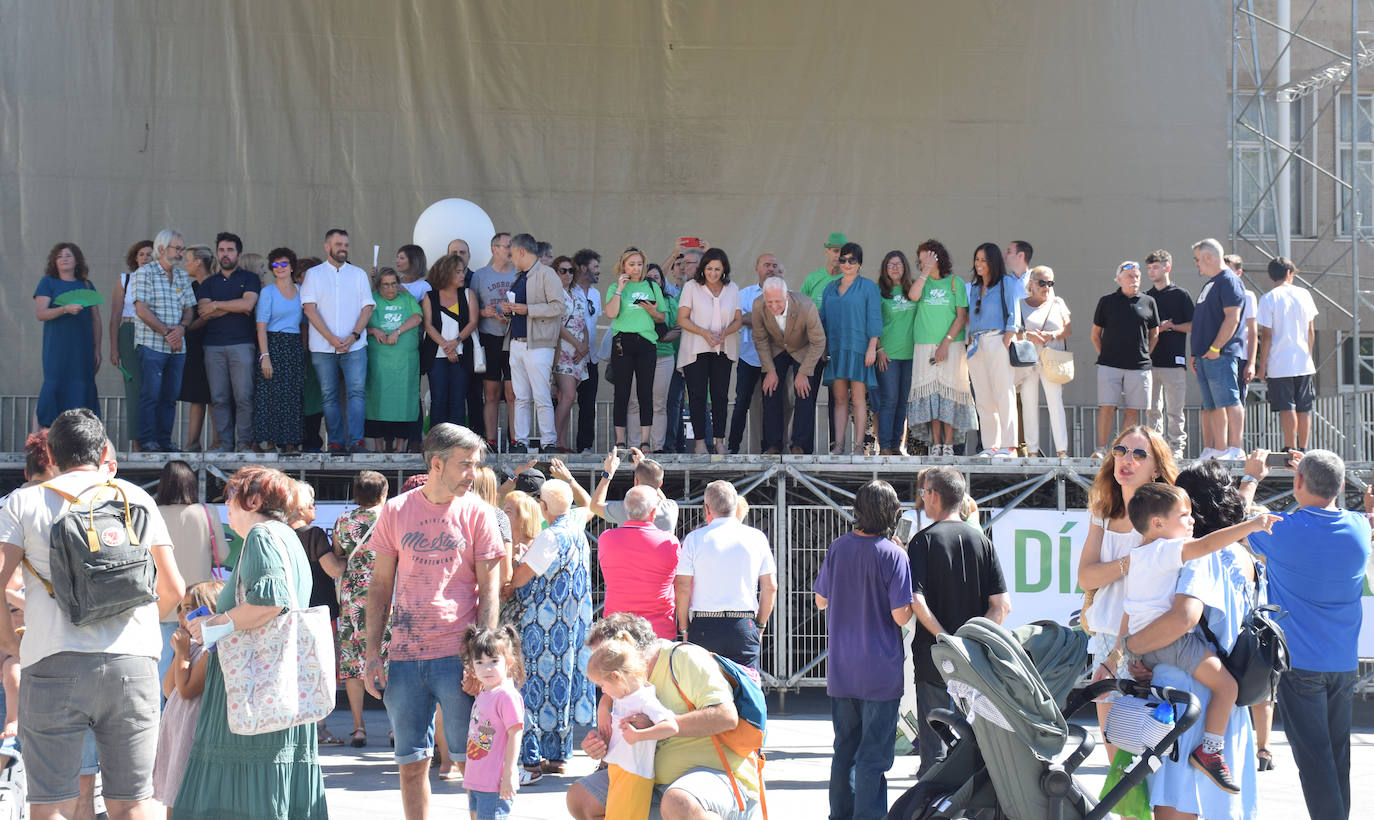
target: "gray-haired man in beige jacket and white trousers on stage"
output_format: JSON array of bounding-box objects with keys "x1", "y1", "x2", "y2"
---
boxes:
[{"x1": 500, "y1": 234, "x2": 567, "y2": 453}]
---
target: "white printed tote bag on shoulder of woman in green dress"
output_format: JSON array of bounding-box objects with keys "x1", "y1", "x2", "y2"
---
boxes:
[{"x1": 217, "y1": 525, "x2": 337, "y2": 735}]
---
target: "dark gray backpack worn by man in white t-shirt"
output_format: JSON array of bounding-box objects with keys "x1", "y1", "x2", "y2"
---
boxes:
[{"x1": 23, "y1": 479, "x2": 158, "y2": 626}]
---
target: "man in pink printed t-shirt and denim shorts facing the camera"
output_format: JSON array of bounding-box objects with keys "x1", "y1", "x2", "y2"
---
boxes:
[{"x1": 363, "y1": 423, "x2": 506, "y2": 820}]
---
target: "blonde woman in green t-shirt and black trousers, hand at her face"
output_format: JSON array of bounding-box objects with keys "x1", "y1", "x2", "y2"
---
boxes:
[{"x1": 606, "y1": 247, "x2": 666, "y2": 446}]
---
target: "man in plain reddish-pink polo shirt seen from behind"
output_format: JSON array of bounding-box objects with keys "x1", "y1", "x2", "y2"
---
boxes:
[{"x1": 596, "y1": 485, "x2": 680, "y2": 640}]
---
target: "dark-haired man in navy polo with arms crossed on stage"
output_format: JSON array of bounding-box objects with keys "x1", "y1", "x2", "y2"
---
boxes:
[{"x1": 196, "y1": 232, "x2": 262, "y2": 452}]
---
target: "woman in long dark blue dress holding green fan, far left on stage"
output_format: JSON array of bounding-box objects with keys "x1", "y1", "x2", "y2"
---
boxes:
[{"x1": 33, "y1": 242, "x2": 100, "y2": 427}]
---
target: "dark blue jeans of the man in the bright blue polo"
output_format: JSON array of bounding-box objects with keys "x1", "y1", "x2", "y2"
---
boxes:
[{"x1": 1278, "y1": 669, "x2": 1355, "y2": 819}]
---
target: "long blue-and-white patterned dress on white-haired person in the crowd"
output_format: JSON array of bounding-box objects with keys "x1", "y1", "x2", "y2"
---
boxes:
[{"x1": 517, "y1": 514, "x2": 596, "y2": 765}]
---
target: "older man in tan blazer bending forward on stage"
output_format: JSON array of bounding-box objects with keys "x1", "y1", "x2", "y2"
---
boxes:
[{"x1": 752, "y1": 276, "x2": 826, "y2": 456}]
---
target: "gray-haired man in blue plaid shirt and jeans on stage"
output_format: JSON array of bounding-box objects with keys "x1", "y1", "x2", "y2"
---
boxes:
[{"x1": 132, "y1": 229, "x2": 195, "y2": 452}]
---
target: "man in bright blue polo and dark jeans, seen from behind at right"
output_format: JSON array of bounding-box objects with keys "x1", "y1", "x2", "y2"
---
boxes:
[{"x1": 1242, "y1": 449, "x2": 1374, "y2": 817}]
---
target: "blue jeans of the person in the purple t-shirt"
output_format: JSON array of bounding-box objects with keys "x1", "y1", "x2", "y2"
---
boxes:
[{"x1": 830, "y1": 698, "x2": 901, "y2": 820}]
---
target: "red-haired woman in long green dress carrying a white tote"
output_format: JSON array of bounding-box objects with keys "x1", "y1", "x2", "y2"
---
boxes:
[{"x1": 173, "y1": 467, "x2": 328, "y2": 820}]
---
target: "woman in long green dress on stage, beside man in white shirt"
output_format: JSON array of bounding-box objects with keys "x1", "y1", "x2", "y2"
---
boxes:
[{"x1": 364, "y1": 268, "x2": 423, "y2": 453}]
